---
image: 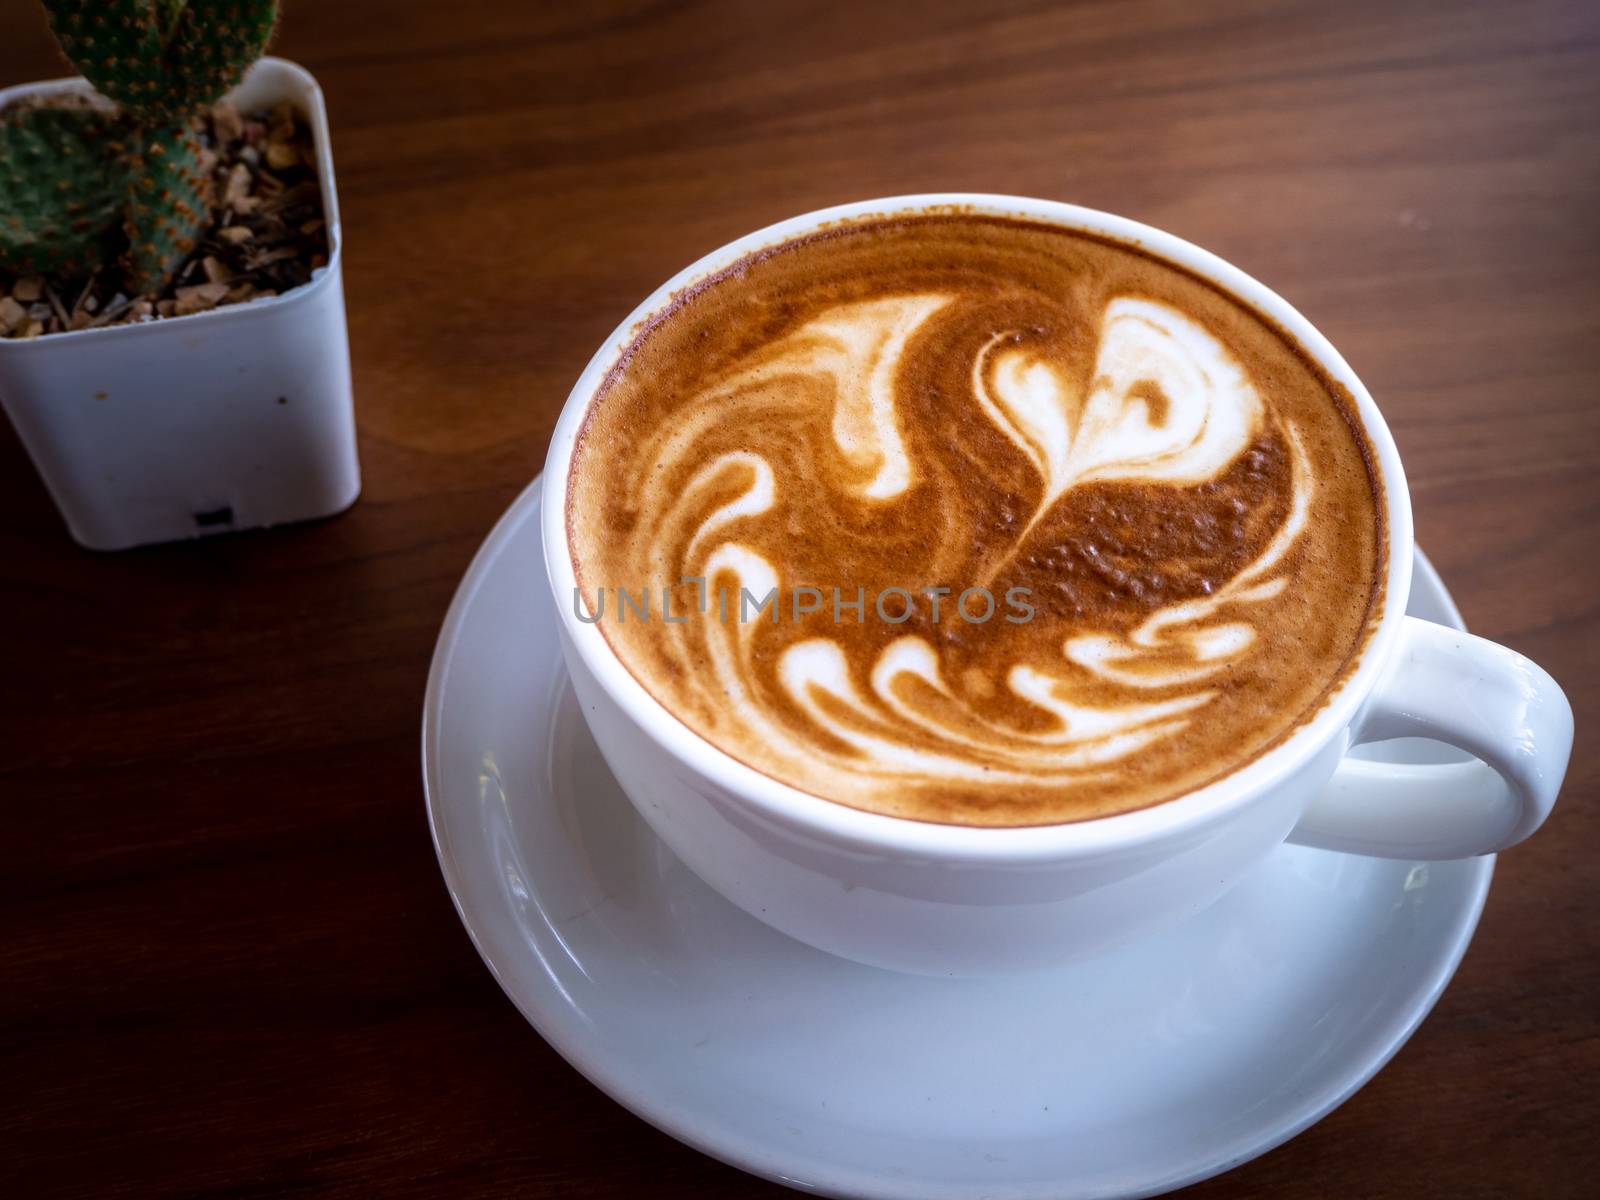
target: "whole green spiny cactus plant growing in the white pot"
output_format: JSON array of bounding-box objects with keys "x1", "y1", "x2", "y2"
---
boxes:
[{"x1": 0, "y1": 0, "x2": 277, "y2": 293}]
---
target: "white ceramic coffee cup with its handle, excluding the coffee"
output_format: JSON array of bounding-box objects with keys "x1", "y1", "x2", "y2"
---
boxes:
[{"x1": 542, "y1": 194, "x2": 1573, "y2": 974}]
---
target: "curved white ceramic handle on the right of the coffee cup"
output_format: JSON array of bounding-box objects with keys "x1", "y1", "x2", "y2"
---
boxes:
[{"x1": 1288, "y1": 616, "x2": 1573, "y2": 859}]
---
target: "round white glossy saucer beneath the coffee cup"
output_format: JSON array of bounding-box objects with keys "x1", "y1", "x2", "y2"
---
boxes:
[{"x1": 422, "y1": 482, "x2": 1493, "y2": 1200}]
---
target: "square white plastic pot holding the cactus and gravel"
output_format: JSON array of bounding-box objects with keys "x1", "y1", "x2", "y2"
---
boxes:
[{"x1": 0, "y1": 58, "x2": 362, "y2": 550}]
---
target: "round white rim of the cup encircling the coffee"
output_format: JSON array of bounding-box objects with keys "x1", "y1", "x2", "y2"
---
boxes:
[{"x1": 541, "y1": 192, "x2": 1413, "y2": 864}]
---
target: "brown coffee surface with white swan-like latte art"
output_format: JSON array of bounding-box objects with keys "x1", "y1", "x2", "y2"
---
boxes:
[{"x1": 562, "y1": 213, "x2": 1386, "y2": 826}]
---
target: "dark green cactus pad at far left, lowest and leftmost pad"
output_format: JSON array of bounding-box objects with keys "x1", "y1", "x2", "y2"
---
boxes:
[{"x1": 0, "y1": 106, "x2": 125, "y2": 275}]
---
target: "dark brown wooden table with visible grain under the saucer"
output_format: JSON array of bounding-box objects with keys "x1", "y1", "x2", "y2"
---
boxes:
[{"x1": 0, "y1": 0, "x2": 1600, "y2": 1200}]
